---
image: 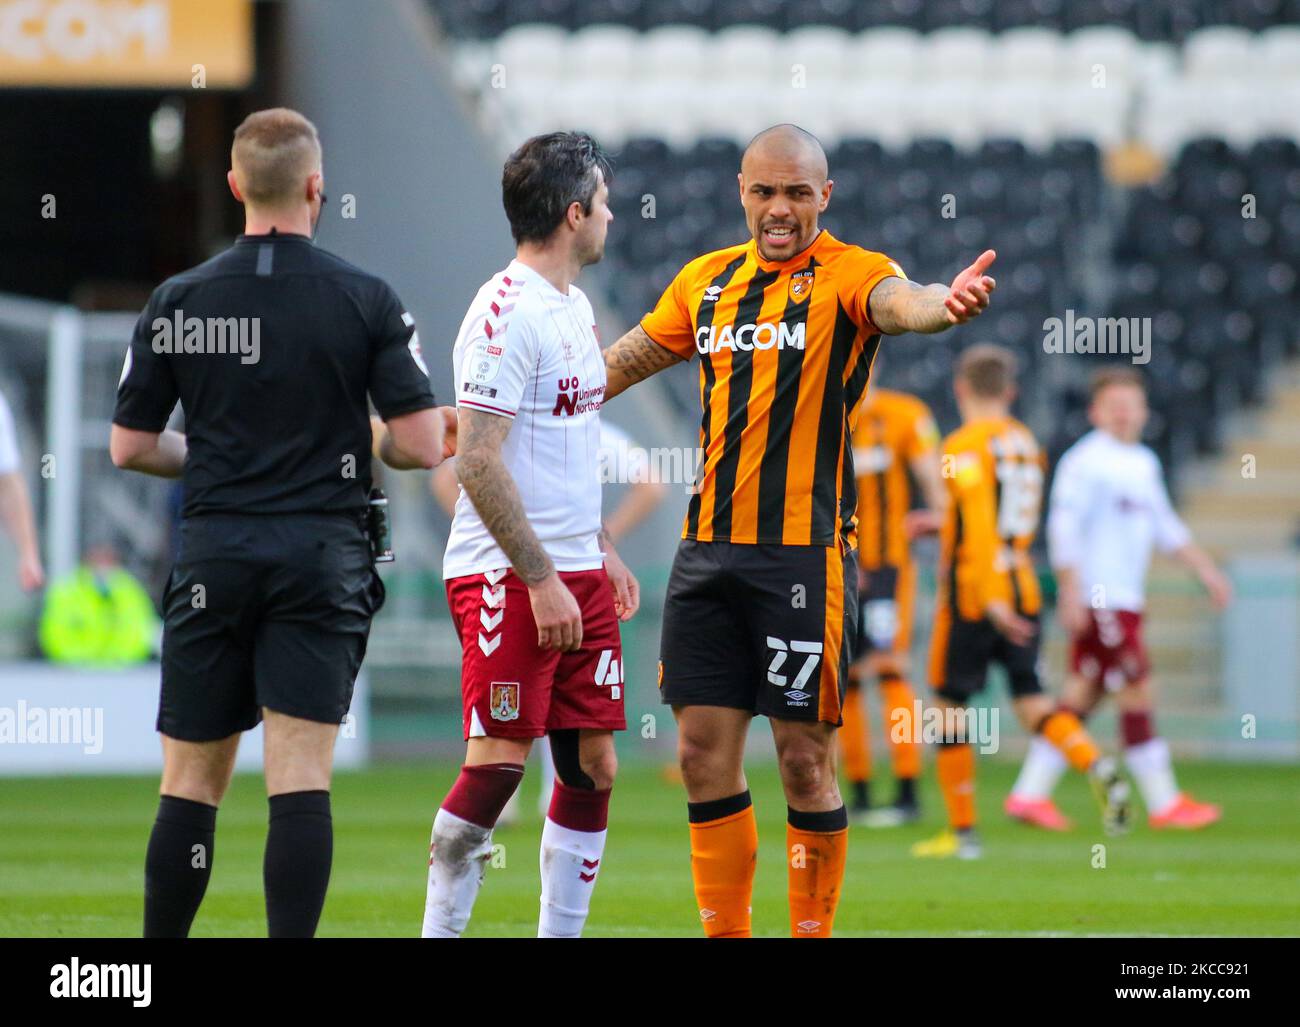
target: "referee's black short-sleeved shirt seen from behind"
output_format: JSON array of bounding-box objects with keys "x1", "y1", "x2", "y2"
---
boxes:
[{"x1": 113, "y1": 231, "x2": 434, "y2": 517}]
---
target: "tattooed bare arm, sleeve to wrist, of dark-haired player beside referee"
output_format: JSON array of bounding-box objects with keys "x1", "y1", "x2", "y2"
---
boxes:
[{"x1": 456, "y1": 408, "x2": 555, "y2": 585}]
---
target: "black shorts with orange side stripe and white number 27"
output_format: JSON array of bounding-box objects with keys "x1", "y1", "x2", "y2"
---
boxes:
[{"x1": 659, "y1": 540, "x2": 858, "y2": 724}]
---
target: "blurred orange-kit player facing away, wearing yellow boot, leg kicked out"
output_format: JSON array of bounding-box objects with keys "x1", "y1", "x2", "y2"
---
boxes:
[{"x1": 913, "y1": 345, "x2": 1128, "y2": 859}]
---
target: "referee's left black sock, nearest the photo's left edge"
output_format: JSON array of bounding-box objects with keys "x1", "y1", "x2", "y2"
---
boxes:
[{"x1": 144, "y1": 796, "x2": 217, "y2": 937}]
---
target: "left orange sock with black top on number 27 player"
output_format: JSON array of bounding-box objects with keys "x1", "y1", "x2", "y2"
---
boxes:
[{"x1": 686, "y1": 792, "x2": 758, "y2": 937}]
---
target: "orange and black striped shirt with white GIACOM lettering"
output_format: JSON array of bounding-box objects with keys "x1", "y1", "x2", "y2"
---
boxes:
[{"x1": 641, "y1": 231, "x2": 906, "y2": 549}]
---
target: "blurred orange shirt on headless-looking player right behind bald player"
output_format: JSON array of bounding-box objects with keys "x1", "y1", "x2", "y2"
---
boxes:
[{"x1": 853, "y1": 387, "x2": 939, "y2": 571}]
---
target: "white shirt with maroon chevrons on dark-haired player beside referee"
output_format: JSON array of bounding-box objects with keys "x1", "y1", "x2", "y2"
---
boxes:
[{"x1": 442, "y1": 260, "x2": 606, "y2": 579}]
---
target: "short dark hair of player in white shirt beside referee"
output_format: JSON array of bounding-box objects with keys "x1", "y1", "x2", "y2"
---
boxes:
[{"x1": 501, "y1": 131, "x2": 614, "y2": 243}]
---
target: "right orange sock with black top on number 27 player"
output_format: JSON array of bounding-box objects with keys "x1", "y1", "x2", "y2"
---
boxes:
[{"x1": 785, "y1": 806, "x2": 849, "y2": 937}]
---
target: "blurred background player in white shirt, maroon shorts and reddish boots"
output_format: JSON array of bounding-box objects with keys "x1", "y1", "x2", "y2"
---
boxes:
[{"x1": 1005, "y1": 367, "x2": 1232, "y2": 831}]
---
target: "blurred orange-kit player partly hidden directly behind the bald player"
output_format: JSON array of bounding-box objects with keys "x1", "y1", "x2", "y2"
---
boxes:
[{"x1": 840, "y1": 379, "x2": 944, "y2": 827}]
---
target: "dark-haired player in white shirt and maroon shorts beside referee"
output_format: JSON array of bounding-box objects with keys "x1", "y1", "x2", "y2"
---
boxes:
[{"x1": 421, "y1": 133, "x2": 640, "y2": 937}]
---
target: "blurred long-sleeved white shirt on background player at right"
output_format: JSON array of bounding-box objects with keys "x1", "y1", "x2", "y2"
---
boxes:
[{"x1": 1048, "y1": 429, "x2": 1192, "y2": 611}]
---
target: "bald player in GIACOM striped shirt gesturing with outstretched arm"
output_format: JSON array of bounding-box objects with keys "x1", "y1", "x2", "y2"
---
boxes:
[{"x1": 605, "y1": 125, "x2": 995, "y2": 937}]
